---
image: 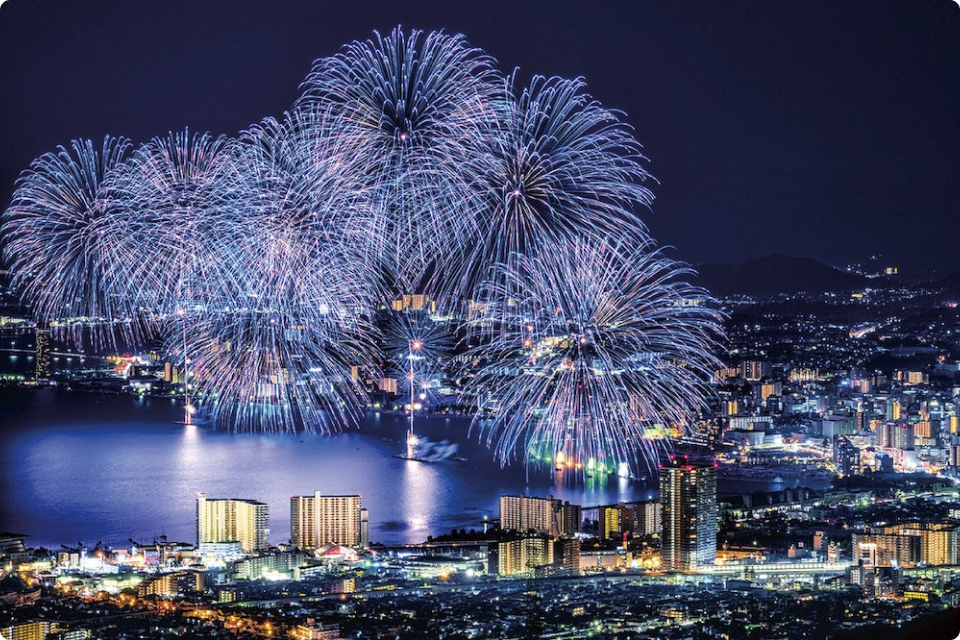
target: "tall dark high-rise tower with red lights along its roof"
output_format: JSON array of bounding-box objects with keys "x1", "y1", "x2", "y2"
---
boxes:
[{"x1": 660, "y1": 458, "x2": 717, "y2": 571}]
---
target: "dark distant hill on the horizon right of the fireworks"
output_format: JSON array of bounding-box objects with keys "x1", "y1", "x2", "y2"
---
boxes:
[{"x1": 696, "y1": 255, "x2": 887, "y2": 296}]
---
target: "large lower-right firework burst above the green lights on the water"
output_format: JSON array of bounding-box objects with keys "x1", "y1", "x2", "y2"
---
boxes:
[{"x1": 467, "y1": 241, "x2": 719, "y2": 471}]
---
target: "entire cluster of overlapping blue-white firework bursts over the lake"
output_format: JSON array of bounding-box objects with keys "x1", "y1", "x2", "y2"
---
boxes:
[{"x1": 2, "y1": 29, "x2": 719, "y2": 467}]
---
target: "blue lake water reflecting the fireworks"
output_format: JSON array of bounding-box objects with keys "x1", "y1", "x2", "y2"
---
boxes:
[{"x1": 0, "y1": 388, "x2": 655, "y2": 546}]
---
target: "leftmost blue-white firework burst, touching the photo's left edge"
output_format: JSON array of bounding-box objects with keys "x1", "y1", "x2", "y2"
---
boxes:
[{"x1": 3, "y1": 136, "x2": 136, "y2": 345}]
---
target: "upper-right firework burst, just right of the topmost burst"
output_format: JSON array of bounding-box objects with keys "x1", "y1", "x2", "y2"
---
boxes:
[{"x1": 460, "y1": 74, "x2": 653, "y2": 292}]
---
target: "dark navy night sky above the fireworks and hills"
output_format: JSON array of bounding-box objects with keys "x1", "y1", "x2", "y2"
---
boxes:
[{"x1": 0, "y1": 0, "x2": 960, "y2": 270}]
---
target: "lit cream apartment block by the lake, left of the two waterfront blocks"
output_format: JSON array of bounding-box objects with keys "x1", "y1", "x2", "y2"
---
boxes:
[{"x1": 197, "y1": 493, "x2": 270, "y2": 553}]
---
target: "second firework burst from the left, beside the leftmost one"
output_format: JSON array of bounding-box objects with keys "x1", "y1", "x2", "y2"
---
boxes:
[{"x1": 105, "y1": 130, "x2": 239, "y2": 318}]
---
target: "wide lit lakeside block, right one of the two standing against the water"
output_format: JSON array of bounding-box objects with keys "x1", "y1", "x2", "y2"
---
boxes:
[{"x1": 290, "y1": 491, "x2": 369, "y2": 549}]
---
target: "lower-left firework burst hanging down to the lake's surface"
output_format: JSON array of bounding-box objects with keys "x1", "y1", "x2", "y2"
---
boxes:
[{"x1": 176, "y1": 233, "x2": 375, "y2": 432}]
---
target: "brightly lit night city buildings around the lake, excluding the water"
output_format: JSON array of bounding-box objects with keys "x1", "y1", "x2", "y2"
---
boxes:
[{"x1": 3, "y1": 263, "x2": 960, "y2": 638}]
